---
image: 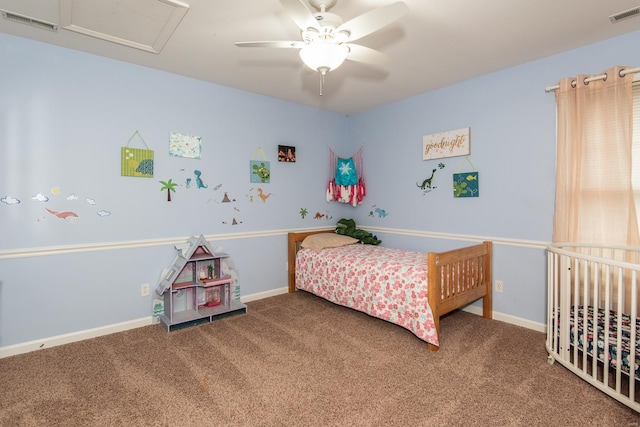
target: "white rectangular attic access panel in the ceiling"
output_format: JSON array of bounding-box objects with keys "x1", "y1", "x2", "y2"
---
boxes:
[{"x1": 60, "y1": 0, "x2": 189, "y2": 53}]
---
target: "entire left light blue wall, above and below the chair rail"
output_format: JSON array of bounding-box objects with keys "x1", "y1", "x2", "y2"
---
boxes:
[{"x1": 0, "y1": 35, "x2": 347, "y2": 347}]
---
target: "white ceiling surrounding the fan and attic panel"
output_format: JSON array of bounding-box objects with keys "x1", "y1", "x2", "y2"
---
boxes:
[{"x1": 0, "y1": 0, "x2": 640, "y2": 115}]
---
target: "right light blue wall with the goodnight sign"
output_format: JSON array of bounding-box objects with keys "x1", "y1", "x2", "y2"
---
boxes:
[{"x1": 349, "y1": 32, "x2": 640, "y2": 323}]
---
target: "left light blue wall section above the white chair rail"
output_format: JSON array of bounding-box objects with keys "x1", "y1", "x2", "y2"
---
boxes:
[{"x1": 0, "y1": 36, "x2": 347, "y2": 250}]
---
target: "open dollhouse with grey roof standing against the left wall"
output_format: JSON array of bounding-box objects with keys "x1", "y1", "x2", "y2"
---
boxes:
[{"x1": 156, "y1": 235, "x2": 247, "y2": 331}]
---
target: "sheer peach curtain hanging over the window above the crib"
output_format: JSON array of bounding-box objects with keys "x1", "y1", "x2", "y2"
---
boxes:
[{"x1": 553, "y1": 67, "x2": 640, "y2": 246}]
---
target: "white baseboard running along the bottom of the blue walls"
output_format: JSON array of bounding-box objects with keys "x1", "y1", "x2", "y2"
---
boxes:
[{"x1": 0, "y1": 287, "x2": 546, "y2": 359}]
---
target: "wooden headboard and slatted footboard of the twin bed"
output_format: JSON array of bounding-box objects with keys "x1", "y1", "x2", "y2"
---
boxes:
[{"x1": 288, "y1": 229, "x2": 492, "y2": 351}]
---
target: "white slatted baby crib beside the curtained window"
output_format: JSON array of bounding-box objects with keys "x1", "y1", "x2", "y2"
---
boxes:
[{"x1": 546, "y1": 243, "x2": 640, "y2": 412}]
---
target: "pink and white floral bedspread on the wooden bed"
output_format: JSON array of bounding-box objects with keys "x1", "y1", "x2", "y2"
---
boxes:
[{"x1": 296, "y1": 244, "x2": 439, "y2": 345}]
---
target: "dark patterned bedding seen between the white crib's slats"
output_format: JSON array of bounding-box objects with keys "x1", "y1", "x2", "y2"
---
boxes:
[{"x1": 558, "y1": 306, "x2": 640, "y2": 380}]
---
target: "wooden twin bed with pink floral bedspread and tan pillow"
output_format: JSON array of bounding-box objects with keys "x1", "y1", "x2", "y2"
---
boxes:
[{"x1": 288, "y1": 229, "x2": 492, "y2": 351}]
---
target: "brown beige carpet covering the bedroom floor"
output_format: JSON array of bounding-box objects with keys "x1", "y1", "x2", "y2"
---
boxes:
[{"x1": 0, "y1": 292, "x2": 640, "y2": 427}]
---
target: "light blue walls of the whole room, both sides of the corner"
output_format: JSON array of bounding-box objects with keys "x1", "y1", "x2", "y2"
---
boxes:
[{"x1": 0, "y1": 32, "x2": 640, "y2": 347}]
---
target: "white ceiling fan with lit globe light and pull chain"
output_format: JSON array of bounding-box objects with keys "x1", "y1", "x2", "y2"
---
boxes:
[{"x1": 236, "y1": 0, "x2": 409, "y2": 95}]
